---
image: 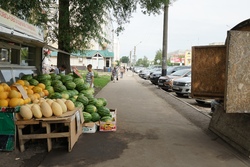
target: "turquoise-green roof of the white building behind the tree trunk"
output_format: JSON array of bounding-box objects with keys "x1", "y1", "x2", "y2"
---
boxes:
[{"x1": 51, "y1": 50, "x2": 114, "y2": 57}]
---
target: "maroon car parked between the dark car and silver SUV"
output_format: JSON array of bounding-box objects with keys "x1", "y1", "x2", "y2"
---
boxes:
[{"x1": 158, "y1": 69, "x2": 191, "y2": 90}]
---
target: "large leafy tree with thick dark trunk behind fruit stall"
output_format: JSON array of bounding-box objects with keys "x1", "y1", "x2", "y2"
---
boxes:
[{"x1": 0, "y1": 0, "x2": 172, "y2": 73}]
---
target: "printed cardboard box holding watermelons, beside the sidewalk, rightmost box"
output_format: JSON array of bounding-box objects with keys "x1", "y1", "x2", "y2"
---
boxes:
[{"x1": 99, "y1": 109, "x2": 117, "y2": 132}]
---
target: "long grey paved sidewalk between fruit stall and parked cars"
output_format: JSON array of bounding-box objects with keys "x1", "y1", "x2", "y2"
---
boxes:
[{"x1": 40, "y1": 71, "x2": 250, "y2": 167}]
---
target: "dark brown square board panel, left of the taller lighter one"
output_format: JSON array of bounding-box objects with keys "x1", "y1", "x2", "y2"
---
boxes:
[{"x1": 191, "y1": 45, "x2": 226, "y2": 99}]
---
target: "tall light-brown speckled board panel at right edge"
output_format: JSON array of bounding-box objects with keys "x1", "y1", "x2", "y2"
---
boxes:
[{"x1": 224, "y1": 31, "x2": 250, "y2": 113}]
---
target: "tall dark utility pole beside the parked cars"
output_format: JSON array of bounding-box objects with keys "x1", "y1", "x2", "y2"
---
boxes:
[{"x1": 161, "y1": 1, "x2": 169, "y2": 76}]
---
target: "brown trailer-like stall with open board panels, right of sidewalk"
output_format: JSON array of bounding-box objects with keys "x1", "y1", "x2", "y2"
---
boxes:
[{"x1": 191, "y1": 19, "x2": 250, "y2": 157}]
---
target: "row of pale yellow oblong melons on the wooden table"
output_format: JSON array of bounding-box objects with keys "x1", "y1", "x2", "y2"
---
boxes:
[{"x1": 17, "y1": 98, "x2": 75, "y2": 120}]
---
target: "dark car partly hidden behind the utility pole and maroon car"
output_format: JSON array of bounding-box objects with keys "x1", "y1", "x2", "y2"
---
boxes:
[{"x1": 149, "y1": 66, "x2": 191, "y2": 85}]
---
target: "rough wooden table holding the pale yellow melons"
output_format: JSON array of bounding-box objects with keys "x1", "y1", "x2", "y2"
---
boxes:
[{"x1": 15, "y1": 108, "x2": 83, "y2": 152}]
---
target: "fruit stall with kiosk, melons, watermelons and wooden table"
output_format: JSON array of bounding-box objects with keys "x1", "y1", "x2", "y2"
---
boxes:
[{"x1": 0, "y1": 9, "x2": 117, "y2": 152}]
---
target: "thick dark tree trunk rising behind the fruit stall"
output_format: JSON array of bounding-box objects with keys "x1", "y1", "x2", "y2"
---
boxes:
[{"x1": 57, "y1": 0, "x2": 71, "y2": 74}]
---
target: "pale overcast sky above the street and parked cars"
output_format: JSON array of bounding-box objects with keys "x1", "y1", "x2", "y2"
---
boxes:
[{"x1": 117, "y1": 0, "x2": 250, "y2": 60}]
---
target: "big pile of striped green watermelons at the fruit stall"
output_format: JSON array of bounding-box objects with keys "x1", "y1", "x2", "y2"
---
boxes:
[{"x1": 22, "y1": 73, "x2": 112, "y2": 122}]
